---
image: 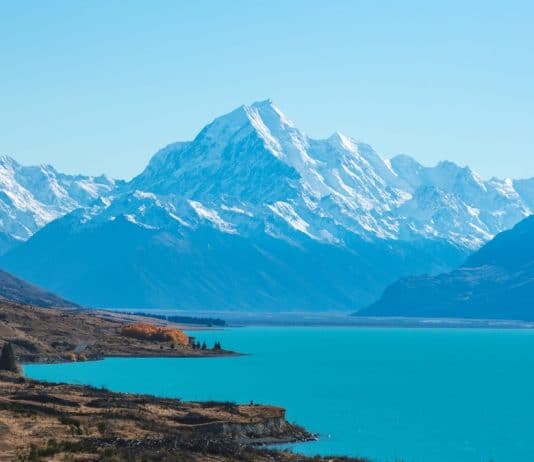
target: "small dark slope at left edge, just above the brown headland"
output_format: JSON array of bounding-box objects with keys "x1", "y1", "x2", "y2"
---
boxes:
[{"x1": 0, "y1": 270, "x2": 78, "y2": 308}]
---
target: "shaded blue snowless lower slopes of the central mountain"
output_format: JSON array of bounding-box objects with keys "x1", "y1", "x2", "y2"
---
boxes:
[{"x1": 0, "y1": 213, "x2": 468, "y2": 311}]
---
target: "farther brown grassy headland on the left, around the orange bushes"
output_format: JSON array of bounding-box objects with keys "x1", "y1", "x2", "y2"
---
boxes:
[{"x1": 0, "y1": 300, "x2": 235, "y2": 363}]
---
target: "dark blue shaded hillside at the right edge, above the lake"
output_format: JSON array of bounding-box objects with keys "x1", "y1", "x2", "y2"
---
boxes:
[{"x1": 358, "y1": 216, "x2": 534, "y2": 320}]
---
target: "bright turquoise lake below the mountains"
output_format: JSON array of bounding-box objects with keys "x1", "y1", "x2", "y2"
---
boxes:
[{"x1": 24, "y1": 327, "x2": 534, "y2": 462}]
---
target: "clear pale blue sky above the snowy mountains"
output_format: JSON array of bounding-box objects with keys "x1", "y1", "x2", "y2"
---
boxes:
[{"x1": 0, "y1": 0, "x2": 534, "y2": 178}]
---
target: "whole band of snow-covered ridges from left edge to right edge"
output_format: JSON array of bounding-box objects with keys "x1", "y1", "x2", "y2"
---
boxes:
[{"x1": 0, "y1": 100, "x2": 534, "y2": 250}]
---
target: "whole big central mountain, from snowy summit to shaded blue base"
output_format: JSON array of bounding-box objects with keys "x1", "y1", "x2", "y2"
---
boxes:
[{"x1": 0, "y1": 101, "x2": 534, "y2": 311}]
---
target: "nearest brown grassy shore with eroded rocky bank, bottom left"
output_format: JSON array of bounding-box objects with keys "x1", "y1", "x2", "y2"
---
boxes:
[{"x1": 0, "y1": 372, "x2": 344, "y2": 461}]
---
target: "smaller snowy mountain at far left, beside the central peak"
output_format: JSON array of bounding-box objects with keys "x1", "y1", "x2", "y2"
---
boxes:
[{"x1": 0, "y1": 156, "x2": 116, "y2": 249}]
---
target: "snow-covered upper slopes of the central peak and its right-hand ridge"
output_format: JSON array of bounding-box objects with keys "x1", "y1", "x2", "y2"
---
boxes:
[{"x1": 95, "y1": 101, "x2": 534, "y2": 250}]
